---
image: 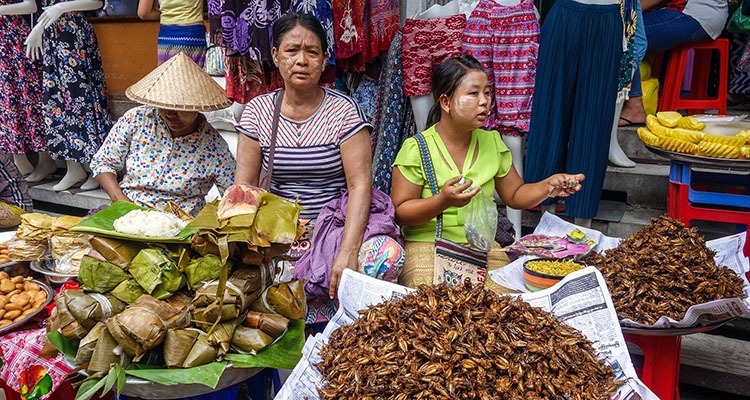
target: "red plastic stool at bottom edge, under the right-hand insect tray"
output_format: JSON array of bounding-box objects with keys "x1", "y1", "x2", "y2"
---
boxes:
[{"x1": 624, "y1": 333, "x2": 682, "y2": 400}]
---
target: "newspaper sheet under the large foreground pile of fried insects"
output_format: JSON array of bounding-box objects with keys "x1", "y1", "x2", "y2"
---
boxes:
[{"x1": 276, "y1": 267, "x2": 658, "y2": 400}]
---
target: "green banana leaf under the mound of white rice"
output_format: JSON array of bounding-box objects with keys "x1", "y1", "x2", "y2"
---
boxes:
[{"x1": 70, "y1": 200, "x2": 198, "y2": 243}]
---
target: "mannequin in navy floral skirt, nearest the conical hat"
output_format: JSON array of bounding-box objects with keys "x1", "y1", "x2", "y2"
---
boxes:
[{"x1": 26, "y1": 0, "x2": 112, "y2": 191}]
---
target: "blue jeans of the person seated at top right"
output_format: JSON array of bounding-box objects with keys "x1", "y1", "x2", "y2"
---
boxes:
[{"x1": 630, "y1": 9, "x2": 711, "y2": 97}]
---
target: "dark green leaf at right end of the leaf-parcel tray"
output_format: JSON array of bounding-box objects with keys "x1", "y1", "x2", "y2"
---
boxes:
[{"x1": 224, "y1": 319, "x2": 305, "y2": 369}]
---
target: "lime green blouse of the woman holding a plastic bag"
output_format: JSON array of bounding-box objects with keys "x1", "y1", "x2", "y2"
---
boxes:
[{"x1": 393, "y1": 125, "x2": 512, "y2": 243}]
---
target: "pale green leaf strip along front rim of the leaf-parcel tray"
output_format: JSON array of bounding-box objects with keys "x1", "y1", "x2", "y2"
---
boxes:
[{"x1": 125, "y1": 361, "x2": 227, "y2": 389}]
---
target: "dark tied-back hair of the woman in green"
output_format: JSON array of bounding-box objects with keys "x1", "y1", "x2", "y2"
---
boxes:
[{"x1": 427, "y1": 54, "x2": 484, "y2": 127}]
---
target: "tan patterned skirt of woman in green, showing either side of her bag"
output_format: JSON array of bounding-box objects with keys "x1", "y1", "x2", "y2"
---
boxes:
[{"x1": 398, "y1": 242, "x2": 512, "y2": 294}]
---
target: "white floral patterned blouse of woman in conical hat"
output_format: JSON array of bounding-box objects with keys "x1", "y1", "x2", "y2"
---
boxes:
[{"x1": 91, "y1": 106, "x2": 236, "y2": 216}]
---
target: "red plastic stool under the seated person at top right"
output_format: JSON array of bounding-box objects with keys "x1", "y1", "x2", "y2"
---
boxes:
[{"x1": 659, "y1": 39, "x2": 729, "y2": 114}]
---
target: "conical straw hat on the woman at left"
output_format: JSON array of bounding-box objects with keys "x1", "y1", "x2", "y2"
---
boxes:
[{"x1": 125, "y1": 52, "x2": 232, "y2": 111}]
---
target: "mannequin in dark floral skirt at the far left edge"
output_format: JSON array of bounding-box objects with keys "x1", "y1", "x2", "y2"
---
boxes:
[{"x1": 0, "y1": 0, "x2": 57, "y2": 178}]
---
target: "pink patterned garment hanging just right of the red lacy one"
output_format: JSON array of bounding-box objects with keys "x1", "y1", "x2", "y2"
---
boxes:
[{"x1": 463, "y1": 0, "x2": 539, "y2": 136}]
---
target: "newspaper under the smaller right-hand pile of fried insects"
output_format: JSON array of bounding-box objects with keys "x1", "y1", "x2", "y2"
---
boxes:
[{"x1": 490, "y1": 213, "x2": 750, "y2": 329}]
